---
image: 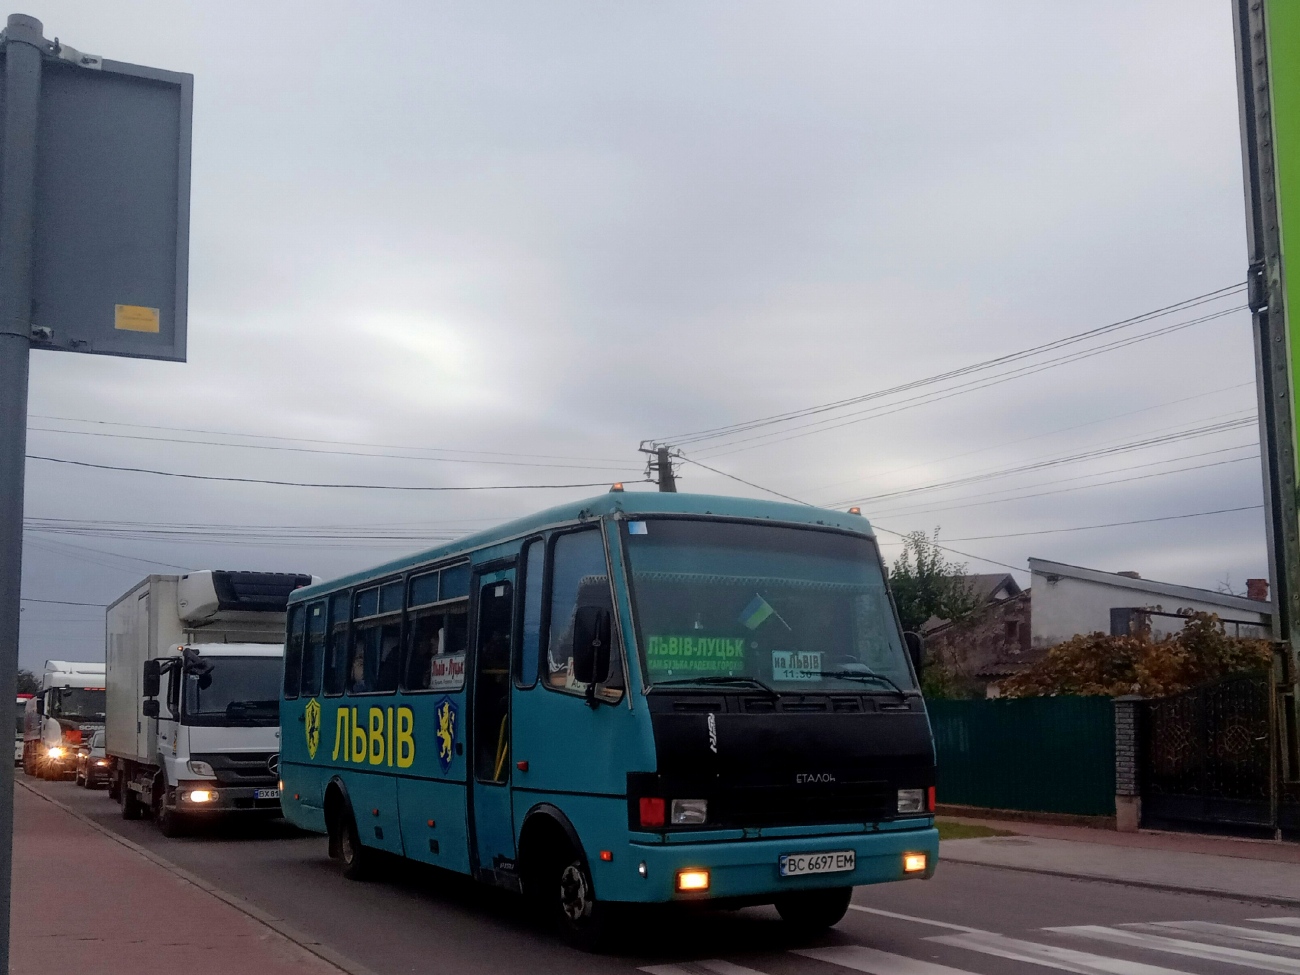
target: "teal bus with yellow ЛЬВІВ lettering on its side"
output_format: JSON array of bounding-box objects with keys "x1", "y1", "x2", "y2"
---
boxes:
[{"x1": 280, "y1": 485, "x2": 939, "y2": 944}]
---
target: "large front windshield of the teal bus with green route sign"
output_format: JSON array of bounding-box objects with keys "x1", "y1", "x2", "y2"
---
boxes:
[{"x1": 627, "y1": 519, "x2": 915, "y2": 694}]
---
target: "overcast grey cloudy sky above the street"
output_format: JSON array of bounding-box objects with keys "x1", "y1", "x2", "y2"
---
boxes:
[{"x1": 21, "y1": 0, "x2": 1266, "y2": 667}]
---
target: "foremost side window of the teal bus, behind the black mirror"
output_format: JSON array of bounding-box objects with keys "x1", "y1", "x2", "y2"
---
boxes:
[{"x1": 546, "y1": 528, "x2": 623, "y2": 694}]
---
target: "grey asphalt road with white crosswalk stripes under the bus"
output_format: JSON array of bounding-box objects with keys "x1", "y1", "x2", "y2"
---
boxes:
[{"x1": 18, "y1": 771, "x2": 1300, "y2": 975}]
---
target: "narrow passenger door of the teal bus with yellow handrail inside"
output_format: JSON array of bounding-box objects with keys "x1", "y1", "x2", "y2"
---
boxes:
[{"x1": 471, "y1": 567, "x2": 517, "y2": 887}]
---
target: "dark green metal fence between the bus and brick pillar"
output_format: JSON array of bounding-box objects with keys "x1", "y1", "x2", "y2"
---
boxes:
[{"x1": 926, "y1": 697, "x2": 1115, "y2": 816}]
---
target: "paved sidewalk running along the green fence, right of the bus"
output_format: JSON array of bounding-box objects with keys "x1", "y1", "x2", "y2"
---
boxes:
[{"x1": 939, "y1": 816, "x2": 1300, "y2": 906}]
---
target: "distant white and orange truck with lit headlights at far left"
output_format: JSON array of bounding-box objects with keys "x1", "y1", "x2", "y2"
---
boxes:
[{"x1": 22, "y1": 660, "x2": 104, "y2": 779}]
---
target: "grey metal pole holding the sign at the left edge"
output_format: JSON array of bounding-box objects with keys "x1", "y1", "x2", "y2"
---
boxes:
[{"x1": 0, "y1": 14, "x2": 46, "y2": 971}]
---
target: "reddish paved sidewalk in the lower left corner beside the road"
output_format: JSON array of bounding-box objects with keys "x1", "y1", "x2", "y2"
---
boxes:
[{"x1": 10, "y1": 779, "x2": 342, "y2": 975}]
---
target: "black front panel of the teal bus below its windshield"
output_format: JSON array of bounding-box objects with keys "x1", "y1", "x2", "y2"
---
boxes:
[{"x1": 628, "y1": 692, "x2": 935, "y2": 829}]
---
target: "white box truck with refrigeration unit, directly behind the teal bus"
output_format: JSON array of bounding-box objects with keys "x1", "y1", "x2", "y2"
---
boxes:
[{"x1": 105, "y1": 569, "x2": 313, "y2": 836}]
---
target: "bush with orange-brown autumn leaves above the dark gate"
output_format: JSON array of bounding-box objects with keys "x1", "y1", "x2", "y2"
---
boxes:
[{"x1": 1001, "y1": 610, "x2": 1273, "y2": 697}]
